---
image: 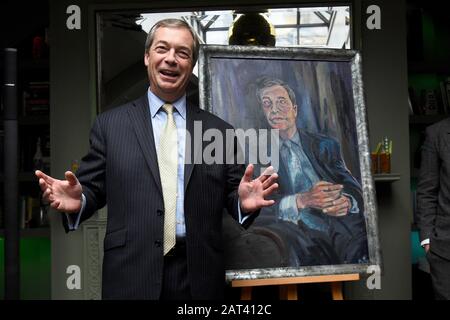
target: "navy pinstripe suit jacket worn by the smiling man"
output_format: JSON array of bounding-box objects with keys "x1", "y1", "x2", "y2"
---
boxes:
[{"x1": 71, "y1": 95, "x2": 245, "y2": 299}]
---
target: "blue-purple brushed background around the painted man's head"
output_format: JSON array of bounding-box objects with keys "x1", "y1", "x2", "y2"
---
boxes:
[{"x1": 209, "y1": 58, "x2": 361, "y2": 182}]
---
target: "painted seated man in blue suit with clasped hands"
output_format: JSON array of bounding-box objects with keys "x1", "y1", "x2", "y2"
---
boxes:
[{"x1": 251, "y1": 77, "x2": 368, "y2": 266}]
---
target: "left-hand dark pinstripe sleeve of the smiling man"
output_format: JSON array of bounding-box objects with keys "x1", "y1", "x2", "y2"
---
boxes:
[{"x1": 62, "y1": 118, "x2": 106, "y2": 232}]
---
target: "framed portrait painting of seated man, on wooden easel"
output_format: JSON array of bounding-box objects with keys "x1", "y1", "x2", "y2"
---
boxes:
[{"x1": 199, "y1": 45, "x2": 381, "y2": 281}]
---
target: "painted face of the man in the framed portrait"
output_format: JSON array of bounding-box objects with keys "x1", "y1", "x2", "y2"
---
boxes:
[{"x1": 260, "y1": 85, "x2": 297, "y2": 133}]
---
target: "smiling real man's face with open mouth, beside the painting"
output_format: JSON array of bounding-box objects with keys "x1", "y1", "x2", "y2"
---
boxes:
[{"x1": 144, "y1": 27, "x2": 194, "y2": 102}]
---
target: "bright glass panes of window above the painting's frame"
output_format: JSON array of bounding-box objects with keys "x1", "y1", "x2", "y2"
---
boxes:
[{"x1": 139, "y1": 6, "x2": 351, "y2": 49}]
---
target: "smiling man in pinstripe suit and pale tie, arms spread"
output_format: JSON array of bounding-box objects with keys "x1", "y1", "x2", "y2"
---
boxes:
[{"x1": 36, "y1": 19, "x2": 277, "y2": 299}]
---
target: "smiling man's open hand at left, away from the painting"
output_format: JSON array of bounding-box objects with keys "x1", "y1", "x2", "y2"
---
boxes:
[{"x1": 35, "y1": 170, "x2": 82, "y2": 213}]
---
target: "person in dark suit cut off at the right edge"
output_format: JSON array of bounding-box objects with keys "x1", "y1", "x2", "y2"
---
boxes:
[{"x1": 416, "y1": 118, "x2": 450, "y2": 300}]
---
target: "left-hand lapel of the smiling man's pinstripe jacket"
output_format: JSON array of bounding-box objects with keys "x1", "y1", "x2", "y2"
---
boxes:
[{"x1": 128, "y1": 94, "x2": 162, "y2": 194}]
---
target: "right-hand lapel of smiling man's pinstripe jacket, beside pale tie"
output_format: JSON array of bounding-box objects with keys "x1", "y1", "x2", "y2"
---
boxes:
[{"x1": 184, "y1": 102, "x2": 203, "y2": 191}]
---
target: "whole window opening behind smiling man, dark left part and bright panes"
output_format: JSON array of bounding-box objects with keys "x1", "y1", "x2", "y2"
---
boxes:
[{"x1": 97, "y1": 6, "x2": 352, "y2": 111}]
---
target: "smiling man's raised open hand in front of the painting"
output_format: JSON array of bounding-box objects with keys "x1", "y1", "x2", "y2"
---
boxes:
[{"x1": 238, "y1": 164, "x2": 278, "y2": 213}]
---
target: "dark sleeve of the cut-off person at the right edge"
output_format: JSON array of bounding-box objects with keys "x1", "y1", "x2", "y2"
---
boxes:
[{"x1": 416, "y1": 128, "x2": 440, "y2": 240}]
